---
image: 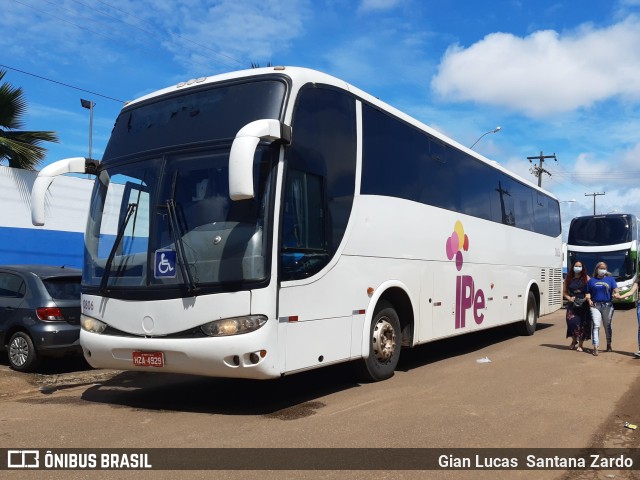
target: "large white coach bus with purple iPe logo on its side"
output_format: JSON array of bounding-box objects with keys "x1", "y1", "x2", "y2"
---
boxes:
[{"x1": 32, "y1": 67, "x2": 562, "y2": 380}]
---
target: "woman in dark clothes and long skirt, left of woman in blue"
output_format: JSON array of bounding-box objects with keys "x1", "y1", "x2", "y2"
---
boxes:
[{"x1": 562, "y1": 260, "x2": 591, "y2": 352}]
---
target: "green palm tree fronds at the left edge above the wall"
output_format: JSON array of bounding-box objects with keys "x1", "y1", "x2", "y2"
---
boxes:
[{"x1": 0, "y1": 70, "x2": 58, "y2": 170}]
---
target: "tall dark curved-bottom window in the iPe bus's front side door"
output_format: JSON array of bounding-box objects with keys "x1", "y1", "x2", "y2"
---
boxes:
[{"x1": 280, "y1": 84, "x2": 357, "y2": 280}]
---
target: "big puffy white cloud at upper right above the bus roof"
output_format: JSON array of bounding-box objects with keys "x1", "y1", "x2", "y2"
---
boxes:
[{"x1": 431, "y1": 16, "x2": 640, "y2": 117}]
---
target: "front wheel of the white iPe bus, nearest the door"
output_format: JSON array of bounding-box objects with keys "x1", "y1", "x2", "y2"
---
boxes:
[{"x1": 359, "y1": 300, "x2": 402, "y2": 382}]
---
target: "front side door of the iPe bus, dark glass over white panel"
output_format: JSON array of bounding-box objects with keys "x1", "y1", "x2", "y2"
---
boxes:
[{"x1": 278, "y1": 83, "x2": 366, "y2": 371}]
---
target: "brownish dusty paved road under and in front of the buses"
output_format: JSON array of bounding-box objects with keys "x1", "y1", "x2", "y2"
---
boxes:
[{"x1": 0, "y1": 310, "x2": 640, "y2": 480}]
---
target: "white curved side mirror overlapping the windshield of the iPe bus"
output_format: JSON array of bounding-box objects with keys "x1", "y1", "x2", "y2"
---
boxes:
[{"x1": 229, "y1": 119, "x2": 291, "y2": 201}]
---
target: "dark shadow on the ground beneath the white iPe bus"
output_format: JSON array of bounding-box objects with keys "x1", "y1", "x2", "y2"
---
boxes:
[{"x1": 65, "y1": 324, "x2": 552, "y2": 420}]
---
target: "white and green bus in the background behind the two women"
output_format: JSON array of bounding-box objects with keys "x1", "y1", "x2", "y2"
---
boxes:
[{"x1": 567, "y1": 213, "x2": 639, "y2": 305}]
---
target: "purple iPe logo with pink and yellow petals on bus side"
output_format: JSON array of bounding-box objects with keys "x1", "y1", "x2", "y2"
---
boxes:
[{"x1": 446, "y1": 220, "x2": 485, "y2": 329}]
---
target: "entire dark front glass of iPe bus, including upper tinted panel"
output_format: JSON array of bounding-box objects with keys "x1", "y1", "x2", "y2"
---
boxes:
[{"x1": 83, "y1": 76, "x2": 287, "y2": 298}]
